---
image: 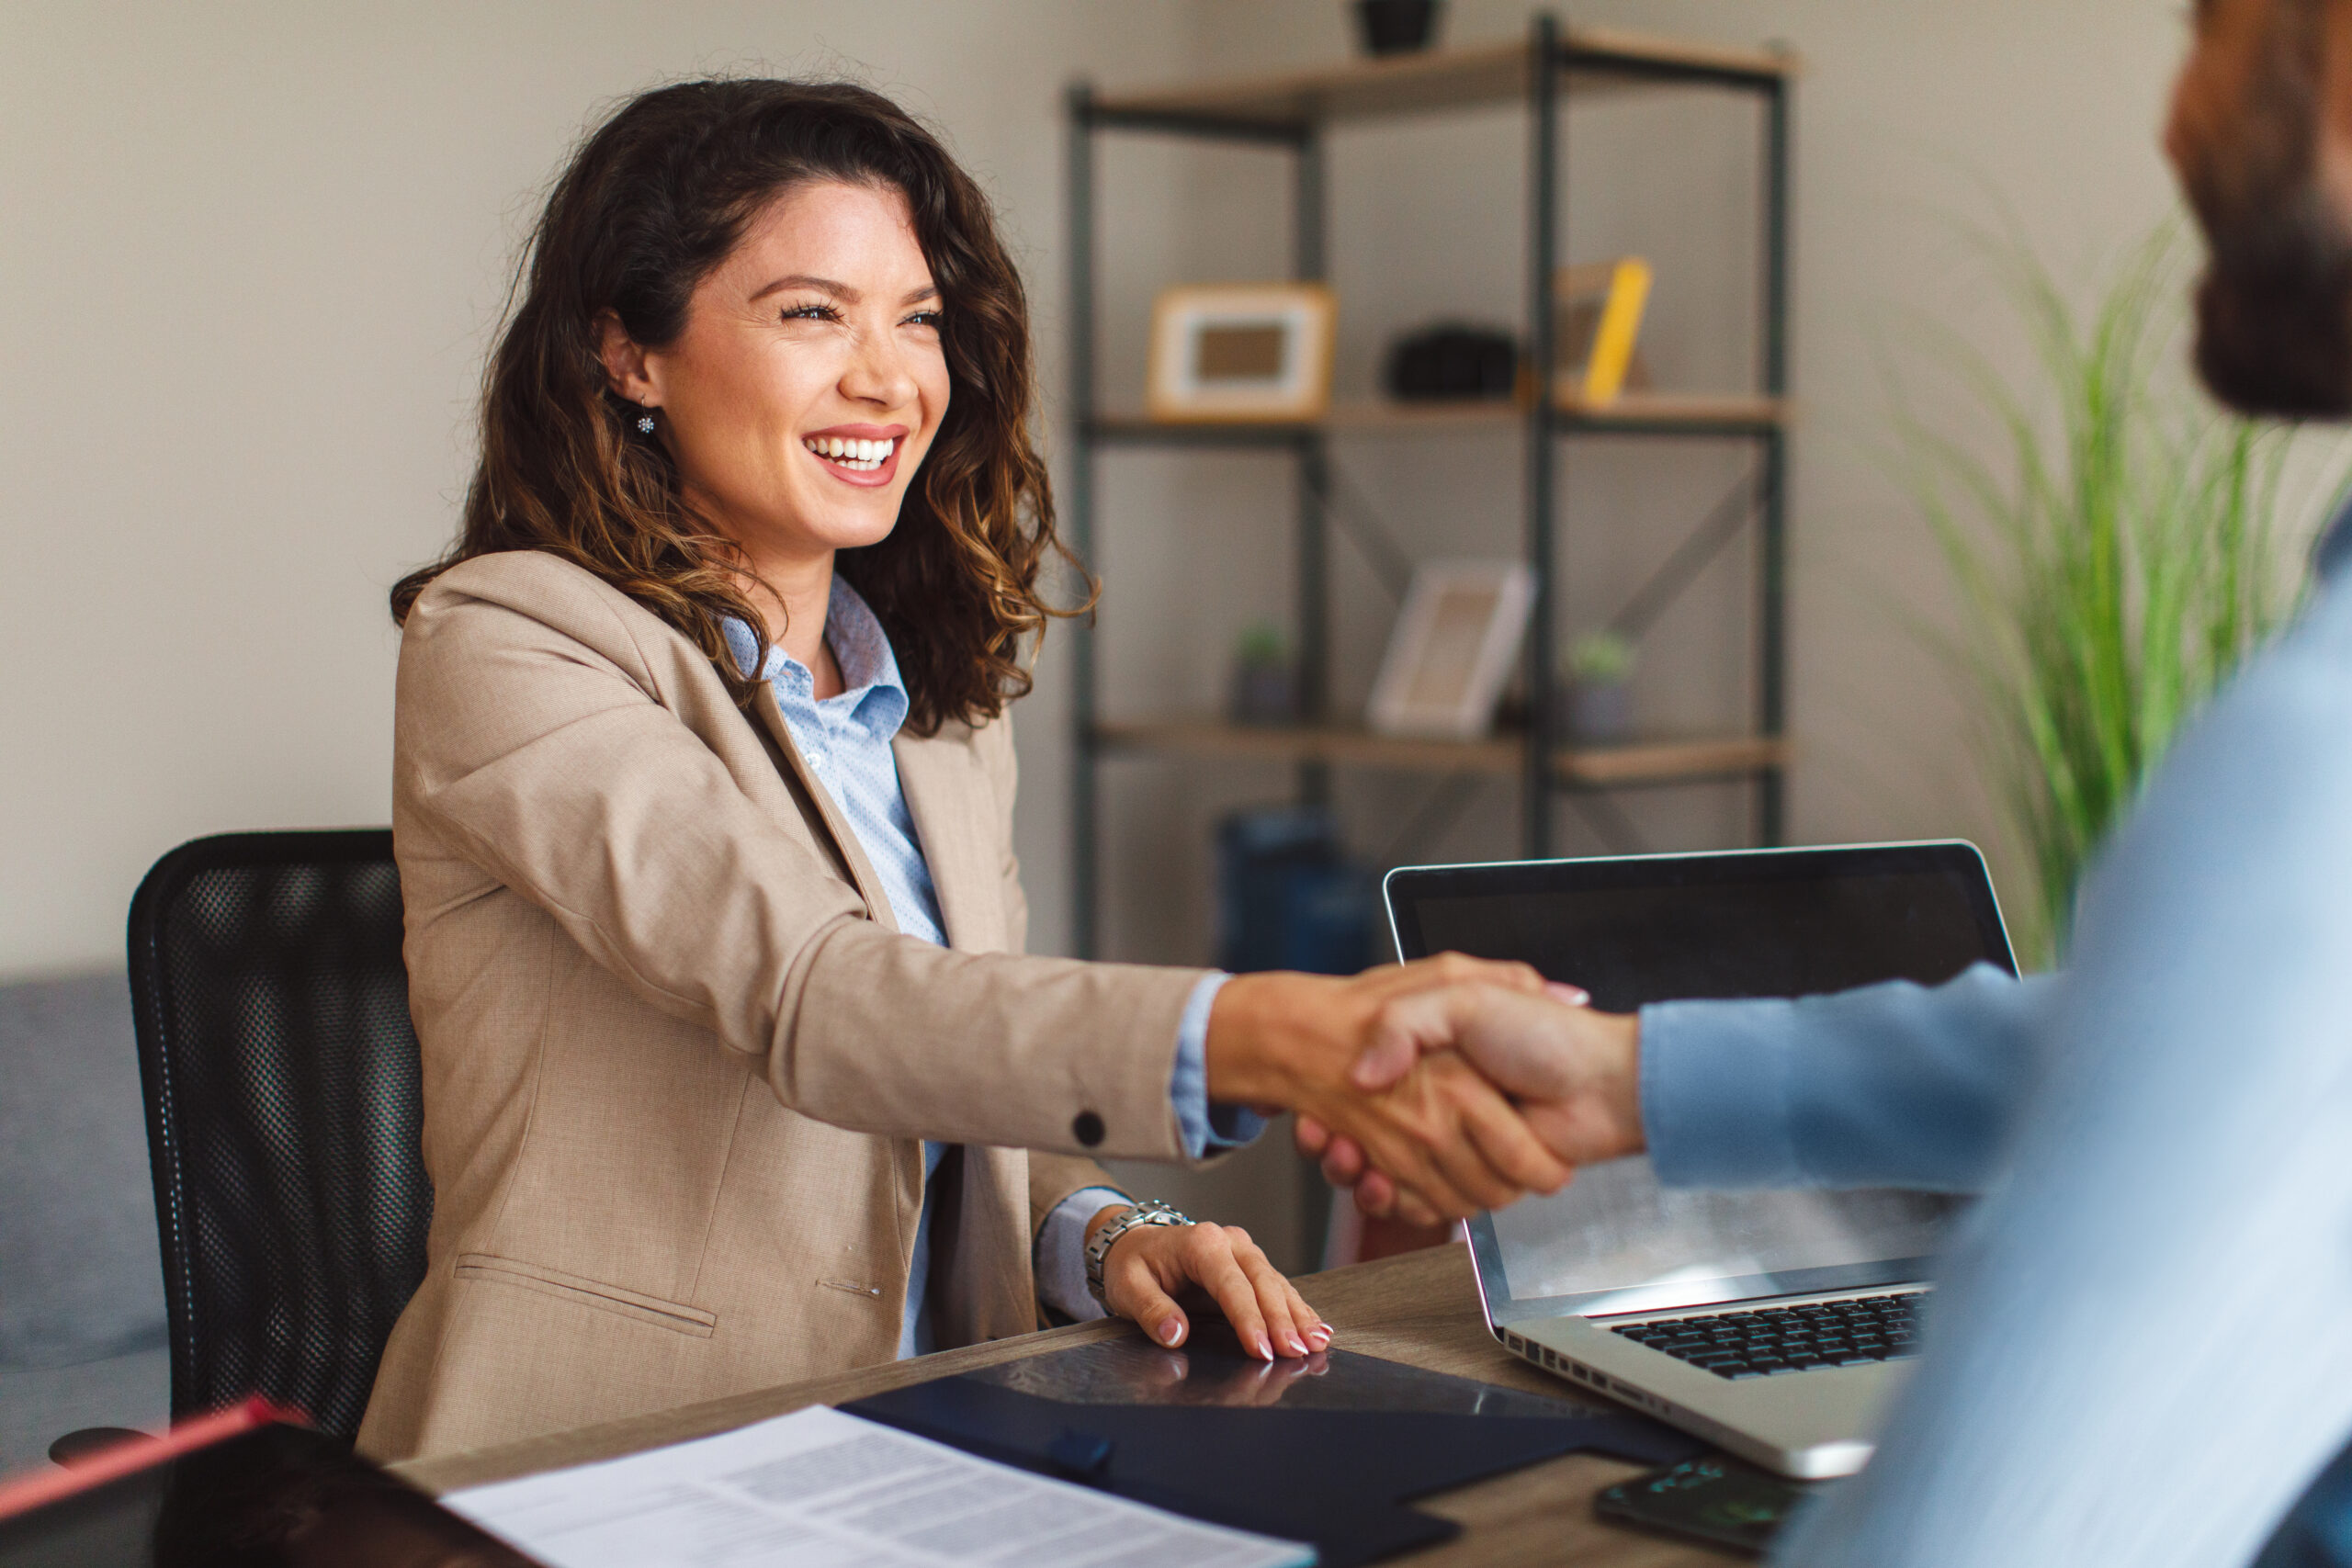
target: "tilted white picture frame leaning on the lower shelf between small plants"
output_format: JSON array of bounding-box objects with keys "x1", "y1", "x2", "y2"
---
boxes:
[{"x1": 1364, "y1": 562, "x2": 1536, "y2": 740}]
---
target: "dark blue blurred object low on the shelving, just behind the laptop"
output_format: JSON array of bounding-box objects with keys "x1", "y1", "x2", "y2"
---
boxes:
[{"x1": 1216, "y1": 807, "x2": 1371, "y2": 976}]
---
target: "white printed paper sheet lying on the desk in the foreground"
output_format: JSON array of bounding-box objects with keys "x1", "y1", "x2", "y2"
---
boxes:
[{"x1": 440, "y1": 1405, "x2": 1315, "y2": 1568}]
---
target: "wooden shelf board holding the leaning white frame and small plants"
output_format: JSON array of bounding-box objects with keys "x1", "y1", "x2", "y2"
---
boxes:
[{"x1": 1093, "y1": 719, "x2": 1788, "y2": 785}]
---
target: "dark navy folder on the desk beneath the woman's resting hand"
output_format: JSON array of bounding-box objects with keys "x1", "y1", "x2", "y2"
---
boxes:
[{"x1": 842, "y1": 1321, "x2": 1705, "y2": 1568}]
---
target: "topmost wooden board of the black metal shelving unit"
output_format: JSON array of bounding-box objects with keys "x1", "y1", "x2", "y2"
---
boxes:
[{"x1": 1093, "y1": 28, "x2": 1797, "y2": 125}]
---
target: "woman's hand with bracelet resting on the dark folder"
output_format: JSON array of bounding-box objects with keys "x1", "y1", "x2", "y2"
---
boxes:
[{"x1": 1087, "y1": 1206, "x2": 1331, "y2": 1361}]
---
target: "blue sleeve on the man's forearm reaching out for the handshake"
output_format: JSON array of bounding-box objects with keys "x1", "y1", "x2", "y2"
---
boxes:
[{"x1": 1642, "y1": 964, "x2": 2051, "y2": 1192}]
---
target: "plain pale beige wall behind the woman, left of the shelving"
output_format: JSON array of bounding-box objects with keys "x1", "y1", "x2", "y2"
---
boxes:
[{"x1": 0, "y1": 0, "x2": 1190, "y2": 978}]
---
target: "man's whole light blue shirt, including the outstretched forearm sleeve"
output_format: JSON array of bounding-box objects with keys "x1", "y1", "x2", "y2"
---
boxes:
[{"x1": 1642, "y1": 512, "x2": 2352, "y2": 1568}]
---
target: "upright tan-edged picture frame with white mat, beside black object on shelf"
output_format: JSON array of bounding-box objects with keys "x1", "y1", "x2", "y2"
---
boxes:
[{"x1": 1146, "y1": 282, "x2": 1339, "y2": 421}]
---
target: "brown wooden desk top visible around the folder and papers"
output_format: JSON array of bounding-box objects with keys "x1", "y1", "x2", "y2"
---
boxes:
[{"x1": 393, "y1": 1246, "x2": 1750, "y2": 1568}]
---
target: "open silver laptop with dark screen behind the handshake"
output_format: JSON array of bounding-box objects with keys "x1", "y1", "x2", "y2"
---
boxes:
[{"x1": 1383, "y1": 841, "x2": 2016, "y2": 1479}]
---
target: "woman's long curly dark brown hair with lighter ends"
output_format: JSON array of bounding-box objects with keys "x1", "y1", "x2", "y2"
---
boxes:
[{"x1": 393, "y1": 80, "x2": 1077, "y2": 736}]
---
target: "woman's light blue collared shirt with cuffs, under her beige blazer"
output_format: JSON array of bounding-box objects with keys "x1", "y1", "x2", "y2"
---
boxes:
[{"x1": 724, "y1": 579, "x2": 1265, "y2": 1357}]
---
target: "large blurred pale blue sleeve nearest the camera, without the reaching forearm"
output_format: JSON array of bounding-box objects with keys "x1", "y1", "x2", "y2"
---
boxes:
[{"x1": 1773, "y1": 581, "x2": 2352, "y2": 1568}]
